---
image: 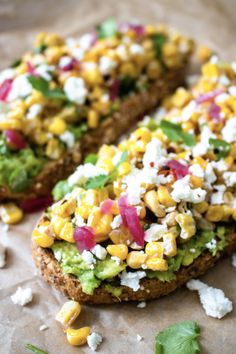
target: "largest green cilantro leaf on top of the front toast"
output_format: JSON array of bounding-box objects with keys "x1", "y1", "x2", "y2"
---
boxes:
[{"x1": 160, "y1": 120, "x2": 196, "y2": 146}]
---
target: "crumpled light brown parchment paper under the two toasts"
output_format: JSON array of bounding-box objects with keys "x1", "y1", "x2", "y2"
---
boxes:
[{"x1": 0, "y1": 0, "x2": 236, "y2": 354}]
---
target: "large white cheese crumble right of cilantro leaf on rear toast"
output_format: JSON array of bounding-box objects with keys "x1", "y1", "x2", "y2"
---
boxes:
[{"x1": 64, "y1": 76, "x2": 88, "y2": 105}]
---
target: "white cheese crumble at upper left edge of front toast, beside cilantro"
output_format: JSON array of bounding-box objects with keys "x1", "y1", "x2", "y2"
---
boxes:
[{"x1": 68, "y1": 163, "x2": 107, "y2": 186}]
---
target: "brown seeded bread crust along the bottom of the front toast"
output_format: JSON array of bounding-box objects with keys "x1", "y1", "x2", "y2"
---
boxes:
[{"x1": 32, "y1": 233, "x2": 236, "y2": 304}]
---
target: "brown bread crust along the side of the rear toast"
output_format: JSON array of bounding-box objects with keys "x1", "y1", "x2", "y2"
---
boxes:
[{"x1": 0, "y1": 66, "x2": 187, "y2": 202}]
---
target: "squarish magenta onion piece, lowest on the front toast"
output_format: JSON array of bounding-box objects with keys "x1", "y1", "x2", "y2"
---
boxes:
[{"x1": 74, "y1": 226, "x2": 96, "y2": 252}]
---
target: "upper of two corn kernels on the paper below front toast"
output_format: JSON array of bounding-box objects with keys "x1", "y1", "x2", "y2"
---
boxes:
[{"x1": 56, "y1": 300, "x2": 81, "y2": 328}]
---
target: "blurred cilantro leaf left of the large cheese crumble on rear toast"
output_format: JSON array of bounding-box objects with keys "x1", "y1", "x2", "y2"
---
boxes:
[{"x1": 28, "y1": 75, "x2": 67, "y2": 101}]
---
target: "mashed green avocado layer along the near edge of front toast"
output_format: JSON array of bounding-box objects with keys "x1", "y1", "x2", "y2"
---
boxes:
[{"x1": 52, "y1": 226, "x2": 227, "y2": 297}]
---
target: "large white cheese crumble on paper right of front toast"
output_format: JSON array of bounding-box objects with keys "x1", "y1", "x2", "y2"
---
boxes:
[{"x1": 187, "y1": 279, "x2": 233, "y2": 319}]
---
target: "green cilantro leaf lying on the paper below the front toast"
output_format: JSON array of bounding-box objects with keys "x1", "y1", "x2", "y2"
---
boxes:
[{"x1": 156, "y1": 321, "x2": 200, "y2": 354}]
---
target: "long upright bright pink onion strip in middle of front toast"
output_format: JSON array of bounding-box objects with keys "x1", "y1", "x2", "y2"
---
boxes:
[{"x1": 118, "y1": 195, "x2": 144, "y2": 247}]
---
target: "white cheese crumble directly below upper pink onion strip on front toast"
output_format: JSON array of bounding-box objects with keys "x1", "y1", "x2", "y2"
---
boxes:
[{"x1": 171, "y1": 175, "x2": 206, "y2": 204}]
